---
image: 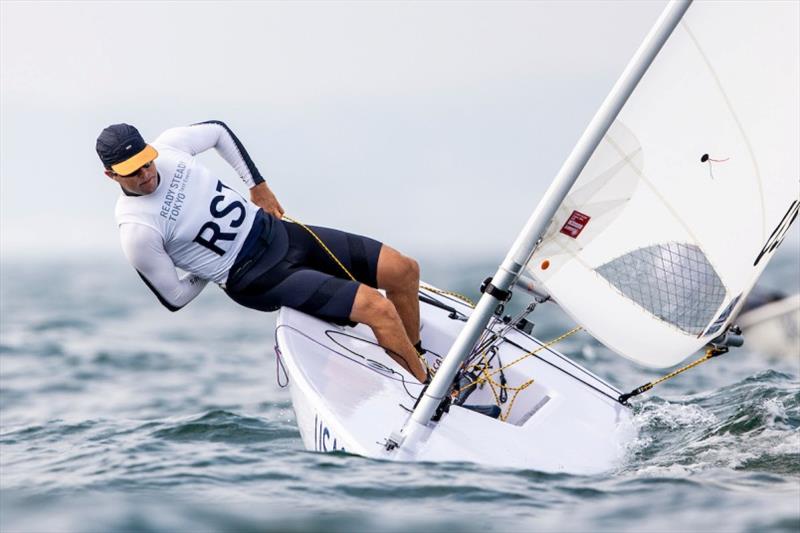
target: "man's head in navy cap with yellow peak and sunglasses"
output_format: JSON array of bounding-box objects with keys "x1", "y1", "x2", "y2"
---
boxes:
[{"x1": 95, "y1": 124, "x2": 158, "y2": 194}]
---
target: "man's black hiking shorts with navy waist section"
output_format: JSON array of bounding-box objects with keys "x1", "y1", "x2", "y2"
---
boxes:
[{"x1": 225, "y1": 211, "x2": 383, "y2": 324}]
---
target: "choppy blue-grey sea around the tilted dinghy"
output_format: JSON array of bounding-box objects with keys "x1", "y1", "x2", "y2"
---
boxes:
[{"x1": 0, "y1": 250, "x2": 800, "y2": 533}]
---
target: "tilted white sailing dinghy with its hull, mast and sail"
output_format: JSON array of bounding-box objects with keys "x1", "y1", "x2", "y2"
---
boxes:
[{"x1": 276, "y1": 1, "x2": 800, "y2": 474}]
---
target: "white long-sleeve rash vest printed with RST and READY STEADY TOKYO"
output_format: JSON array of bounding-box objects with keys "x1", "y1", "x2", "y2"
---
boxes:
[{"x1": 115, "y1": 121, "x2": 264, "y2": 311}]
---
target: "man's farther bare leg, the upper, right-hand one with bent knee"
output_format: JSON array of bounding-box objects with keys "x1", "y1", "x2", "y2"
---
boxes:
[{"x1": 377, "y1": 244, "x2": 419, "y2": 344}]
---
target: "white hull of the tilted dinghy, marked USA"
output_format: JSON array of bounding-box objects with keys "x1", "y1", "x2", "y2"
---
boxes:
[{"x1": 276, "y1": 284, "x2": 634, "y2": 474}]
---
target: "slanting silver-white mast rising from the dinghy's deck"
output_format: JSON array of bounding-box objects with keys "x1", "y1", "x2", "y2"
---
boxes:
[{"x1": 386, "y1": 0, "x2": 692, "y2": 453}]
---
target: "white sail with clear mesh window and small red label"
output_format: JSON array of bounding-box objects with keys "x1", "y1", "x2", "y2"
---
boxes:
[{"x1": 527, "y1": 2, "x2": 800, "y2": 367}]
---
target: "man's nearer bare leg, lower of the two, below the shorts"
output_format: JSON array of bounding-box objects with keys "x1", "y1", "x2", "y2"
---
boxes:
[{"x1": 350, "y1": 284, "x2": 427, "y2": 383}]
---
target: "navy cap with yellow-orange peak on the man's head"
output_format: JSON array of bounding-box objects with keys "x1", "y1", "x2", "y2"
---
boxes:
[{"x1": 95, "y1": 124, "x2": 158, "y2": 176}]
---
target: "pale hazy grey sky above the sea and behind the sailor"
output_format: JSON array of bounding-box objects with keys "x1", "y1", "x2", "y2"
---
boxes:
[{"x1": 0, "y1": 1, "x2": 796, "y2": 259}]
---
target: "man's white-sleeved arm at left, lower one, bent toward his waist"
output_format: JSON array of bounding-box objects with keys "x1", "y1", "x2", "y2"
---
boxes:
[{"x1": 119, "y1": 223, "x2": 208, "y2": 311}]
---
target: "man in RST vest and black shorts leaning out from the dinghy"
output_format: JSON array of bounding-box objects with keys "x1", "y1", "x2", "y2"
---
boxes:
[{"x1": 96, "y1": 121, "x2": 429, "y2": 382}]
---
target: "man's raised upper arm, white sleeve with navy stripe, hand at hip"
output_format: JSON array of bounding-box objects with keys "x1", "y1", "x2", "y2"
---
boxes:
[{"x1": 155, "y1": 120, "x2": 283, "y2": 218}]
